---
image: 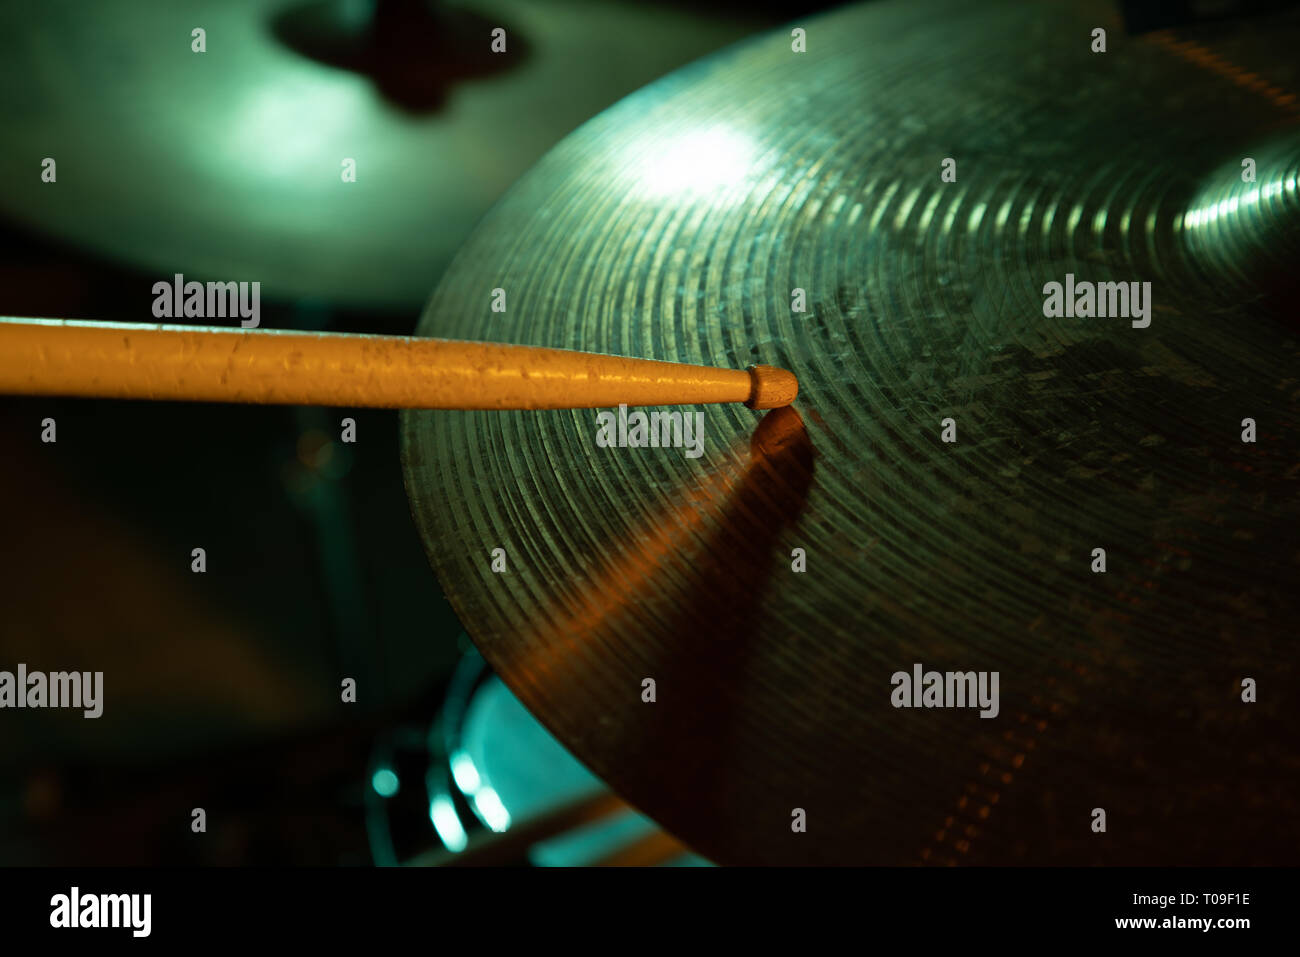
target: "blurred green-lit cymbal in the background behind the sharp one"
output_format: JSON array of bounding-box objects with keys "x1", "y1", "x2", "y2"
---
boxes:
[{"x1": 0, "y1": 0, "x2": 758, "y2": 307}]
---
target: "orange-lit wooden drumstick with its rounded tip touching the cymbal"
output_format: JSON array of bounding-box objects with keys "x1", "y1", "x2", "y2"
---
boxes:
[{"x1": 0, "y1": 317, "x2": 798, "y2": 408}]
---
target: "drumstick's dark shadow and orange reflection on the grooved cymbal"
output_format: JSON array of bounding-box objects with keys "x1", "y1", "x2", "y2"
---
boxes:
[{"x1": 521, "y1": 407, "x2": 815, "y2": 856}]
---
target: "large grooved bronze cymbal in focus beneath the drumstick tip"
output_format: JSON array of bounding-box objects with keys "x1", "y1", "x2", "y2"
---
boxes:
[{"x1": 403, "y1": 0, "x2": 1300, "y2": 863}]
